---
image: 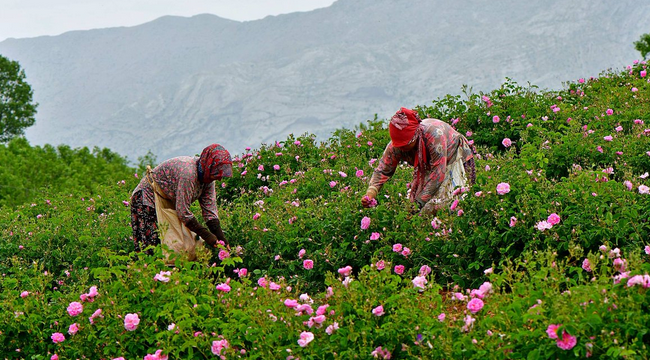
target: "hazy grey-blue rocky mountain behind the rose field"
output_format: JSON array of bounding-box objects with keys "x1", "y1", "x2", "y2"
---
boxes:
[{"x1": 0, "y1": 0, "x2": 650, "y2": 160}]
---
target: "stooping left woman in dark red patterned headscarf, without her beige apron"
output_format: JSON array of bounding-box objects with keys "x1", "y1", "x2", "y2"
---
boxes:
[{"x1": 131, "y1": 144, "x2": 232, "y2": 251}]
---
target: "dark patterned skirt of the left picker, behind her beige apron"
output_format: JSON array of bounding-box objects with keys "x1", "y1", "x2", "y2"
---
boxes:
[{"x1": 131, "y1": 191, "x2": 160, "y2": 253}]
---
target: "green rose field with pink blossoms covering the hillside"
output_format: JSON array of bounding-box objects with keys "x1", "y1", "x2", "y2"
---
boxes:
[{"x1": 0, "y1": 62, "x2": 650, "y2": 360}]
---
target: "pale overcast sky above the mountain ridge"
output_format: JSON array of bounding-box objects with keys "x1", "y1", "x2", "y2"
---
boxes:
[{"x1": 0, "y1": 0, "x2": 335, "y2": 41}]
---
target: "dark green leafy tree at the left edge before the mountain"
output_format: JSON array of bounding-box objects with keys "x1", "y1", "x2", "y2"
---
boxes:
[{"x1": 0, "y1": 55, "x2": 38, "y2": 143}]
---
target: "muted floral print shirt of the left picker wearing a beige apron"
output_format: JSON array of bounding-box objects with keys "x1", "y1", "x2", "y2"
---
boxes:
[{"x1": 133, "y1": 156, "x2": 218, "y2": 224}]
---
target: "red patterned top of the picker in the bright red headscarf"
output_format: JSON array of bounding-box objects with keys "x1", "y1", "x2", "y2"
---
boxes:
[{"x1": 370, "y1": 119, "x2": 474, "y2": 207}]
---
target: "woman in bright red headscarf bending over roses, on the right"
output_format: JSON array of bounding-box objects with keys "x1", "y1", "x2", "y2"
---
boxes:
[{"x1": 361, "y1": 108, "x2": 476, "y2": 214}]
